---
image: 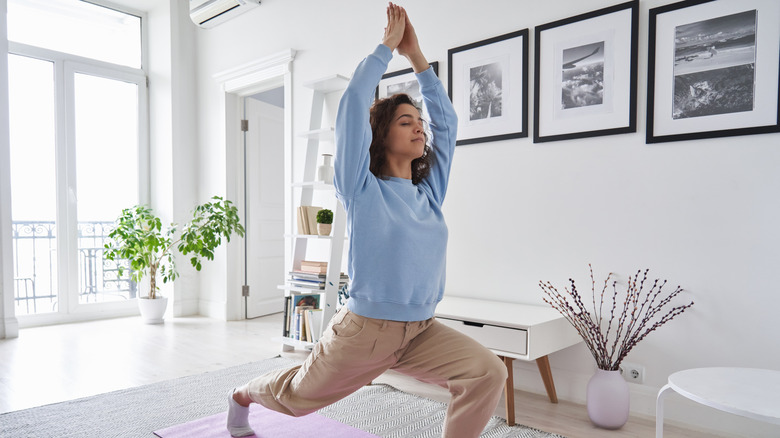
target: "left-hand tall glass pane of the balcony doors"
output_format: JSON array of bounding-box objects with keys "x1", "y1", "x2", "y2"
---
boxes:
[{"x1": 8, "y1": 54, "x2": 58, "y2": 315}]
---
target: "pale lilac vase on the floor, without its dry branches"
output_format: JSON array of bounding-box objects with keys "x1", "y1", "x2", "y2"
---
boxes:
[{"x1": 586, "y1": 370, "x2": 630, "y2": 429}]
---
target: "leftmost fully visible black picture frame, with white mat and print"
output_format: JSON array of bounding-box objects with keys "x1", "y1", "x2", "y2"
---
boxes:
[{"x1": 447, "y1": 29, "x2": 528, "y2": 146}]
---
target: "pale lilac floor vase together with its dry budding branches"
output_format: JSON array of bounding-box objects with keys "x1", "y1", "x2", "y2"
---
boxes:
[{"x1": 539, "y1": 265, "x2": 693, "y2": 429}]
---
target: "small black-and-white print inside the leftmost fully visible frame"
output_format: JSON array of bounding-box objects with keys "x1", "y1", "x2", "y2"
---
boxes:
[{"x1": 469, "y1": 62, "x2": 503, "y2": 120}]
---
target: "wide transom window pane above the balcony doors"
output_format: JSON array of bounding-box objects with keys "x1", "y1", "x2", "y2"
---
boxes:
[{"x1": 8, "y1": 0, "x2": 141, "y2": 68}]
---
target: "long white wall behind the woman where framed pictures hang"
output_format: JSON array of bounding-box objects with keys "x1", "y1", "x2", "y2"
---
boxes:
[{"x1": 190, "y1": 0, "x2": 780, "y2": 436}]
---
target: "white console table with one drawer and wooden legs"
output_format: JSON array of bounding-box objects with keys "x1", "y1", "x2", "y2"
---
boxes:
[{"x1": 436, "y1": 297, "x2": 582, "y2": 426}]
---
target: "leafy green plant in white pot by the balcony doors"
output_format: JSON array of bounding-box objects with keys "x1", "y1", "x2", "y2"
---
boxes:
[{"x1": 104, "y1": 196, "x2": 244, "y2": 324}]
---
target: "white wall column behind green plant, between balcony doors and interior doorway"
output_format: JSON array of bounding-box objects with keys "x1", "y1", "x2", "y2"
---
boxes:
[{"x1": 147, "y1": 0, "x2": 205, "y2": 316}]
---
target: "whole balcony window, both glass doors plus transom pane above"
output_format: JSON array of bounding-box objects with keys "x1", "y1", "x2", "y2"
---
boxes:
[{"x1": 7, "y1": 0, "x2": 149, "y2": 326}]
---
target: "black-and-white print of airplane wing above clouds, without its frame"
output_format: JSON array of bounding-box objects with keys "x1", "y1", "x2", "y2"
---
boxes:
[{"x1": 561, "y1": 41, "x2": 604, "y2": 109}]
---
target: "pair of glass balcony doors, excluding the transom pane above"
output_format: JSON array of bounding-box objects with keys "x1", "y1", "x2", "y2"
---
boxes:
[{"x1": 9, "y1": 54, "x2": 148, "y2": 323}]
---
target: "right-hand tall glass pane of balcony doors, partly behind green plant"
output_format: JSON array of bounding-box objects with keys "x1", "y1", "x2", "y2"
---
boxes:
[{"x1": 74, "y1": 73, "x2": 139, "y2": 303}]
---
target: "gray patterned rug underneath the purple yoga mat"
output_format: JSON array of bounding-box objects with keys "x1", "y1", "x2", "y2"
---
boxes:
[{"x1": 0, "y1": 357, "x2": 563, "y2": 438}]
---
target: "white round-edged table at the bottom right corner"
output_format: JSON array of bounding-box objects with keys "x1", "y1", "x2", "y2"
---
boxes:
[{"x1": 655, "y1": 368, "x2": 780, "y2": 438}]
